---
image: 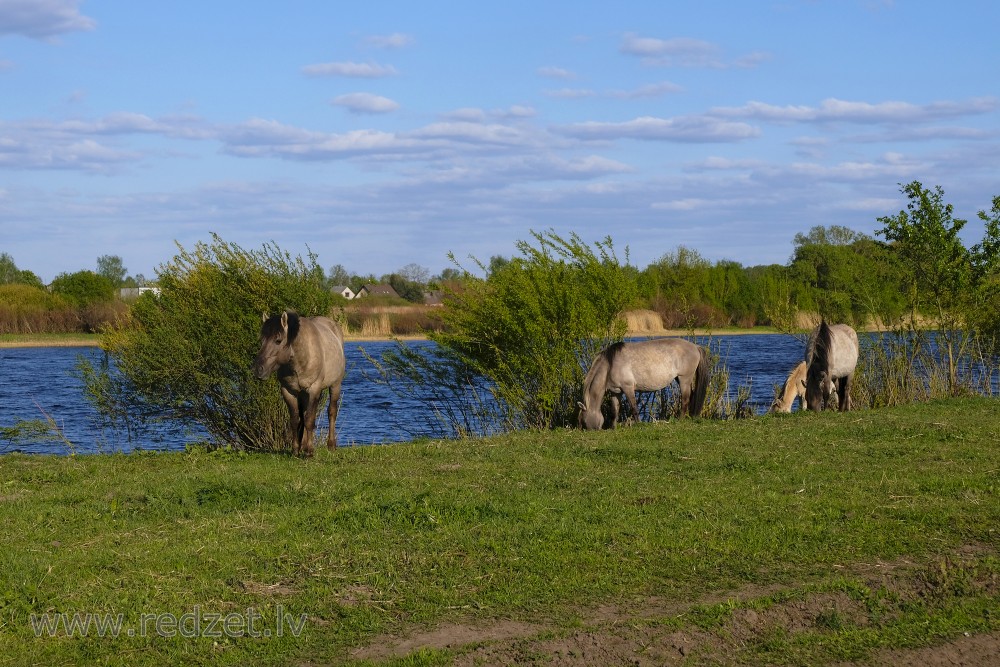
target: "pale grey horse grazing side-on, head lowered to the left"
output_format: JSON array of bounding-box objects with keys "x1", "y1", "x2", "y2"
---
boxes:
[{"x1": 577, "y1": 338, "x2": 708, "y2": 430}]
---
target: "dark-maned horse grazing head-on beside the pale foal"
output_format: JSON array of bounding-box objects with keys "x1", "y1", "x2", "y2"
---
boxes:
[{"x1": 806, "y1": 320, "x2": 860, "y2": 412}]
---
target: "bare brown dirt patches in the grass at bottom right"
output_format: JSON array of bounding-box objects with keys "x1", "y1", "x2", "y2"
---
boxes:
[{"x1": 349, "y1": 547, "x2": 1000, "y2": 667}]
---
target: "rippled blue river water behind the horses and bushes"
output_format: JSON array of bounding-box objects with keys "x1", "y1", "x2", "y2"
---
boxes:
[{"x1": 0, "y1": 334, "x2": 803, "y2": 454}]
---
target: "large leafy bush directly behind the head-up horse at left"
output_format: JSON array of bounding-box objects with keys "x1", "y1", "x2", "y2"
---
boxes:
[{"x1": 81, "y1": 235, "x2": 332, "y2": 449}]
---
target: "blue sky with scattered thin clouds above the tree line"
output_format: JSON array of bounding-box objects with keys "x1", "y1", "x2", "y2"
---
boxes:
[{"x1": 0, "y1": 0, "x2": 1000, "y2": 281}]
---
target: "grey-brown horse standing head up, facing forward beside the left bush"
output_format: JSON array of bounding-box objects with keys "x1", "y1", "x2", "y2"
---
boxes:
[{"x1": 253, "y1": 310, "x2": 347, "y2": 457}]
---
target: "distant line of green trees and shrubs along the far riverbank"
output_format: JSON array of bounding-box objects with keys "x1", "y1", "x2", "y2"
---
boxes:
[{"x1": 0, "y1": 181, "x2": 1000, "y2": 342}]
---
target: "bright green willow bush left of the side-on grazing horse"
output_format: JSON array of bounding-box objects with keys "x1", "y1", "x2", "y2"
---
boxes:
[{"x1": 378, "y1": 231, "x2": 636, "y2": 432}]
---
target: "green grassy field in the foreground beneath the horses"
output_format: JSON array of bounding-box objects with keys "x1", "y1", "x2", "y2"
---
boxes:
[{"x1": 0, "y1": 399, "x2": 1000, "y2": 665}]
